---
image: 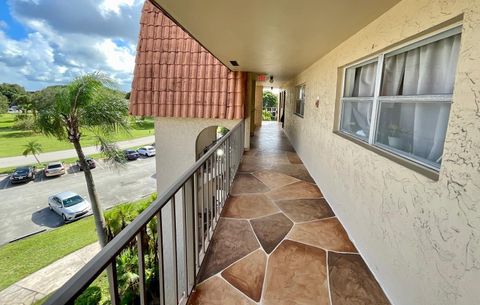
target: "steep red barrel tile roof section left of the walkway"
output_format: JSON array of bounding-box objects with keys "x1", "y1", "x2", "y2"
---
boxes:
[{"x1": 130, "y1": 0, "x2": 246, "y2": 119}]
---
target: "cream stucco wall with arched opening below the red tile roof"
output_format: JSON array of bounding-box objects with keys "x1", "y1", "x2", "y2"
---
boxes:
[{"x1": 155, "y1": 118, "x2": 241, "y2": 195}]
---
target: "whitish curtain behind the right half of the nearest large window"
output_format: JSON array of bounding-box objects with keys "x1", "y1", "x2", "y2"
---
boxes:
[{"x1": 381, "y1": 34, "x2": 460, "y2": 162}]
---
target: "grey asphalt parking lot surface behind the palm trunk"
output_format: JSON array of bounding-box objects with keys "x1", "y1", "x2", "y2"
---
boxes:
[{"x1": 0, "y1": 158, "x2": 156, "y2": 245}]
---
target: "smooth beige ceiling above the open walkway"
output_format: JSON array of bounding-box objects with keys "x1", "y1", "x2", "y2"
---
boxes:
[{"x1": 154, "y1": 0, "x2": 399, "y2": 83}]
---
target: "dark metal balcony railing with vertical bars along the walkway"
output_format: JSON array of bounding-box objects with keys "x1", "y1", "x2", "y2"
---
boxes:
[{"x1": 45, "y1": 121, "x2": 245, "y2": 305}]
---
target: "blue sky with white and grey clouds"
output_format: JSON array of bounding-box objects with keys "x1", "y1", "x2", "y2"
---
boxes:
[{"x1": 0, "y1": 0, "x2": 144, "y2": 91}]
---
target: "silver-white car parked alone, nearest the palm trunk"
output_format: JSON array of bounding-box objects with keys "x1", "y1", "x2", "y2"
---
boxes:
[{"x1": 48, "y1": 192, "x2": 91, "y2": 222}]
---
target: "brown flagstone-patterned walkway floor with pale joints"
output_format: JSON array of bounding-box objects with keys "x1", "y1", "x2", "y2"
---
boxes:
[{"x1": 189, "y1": 123, "x2": 390, "y2": 305}]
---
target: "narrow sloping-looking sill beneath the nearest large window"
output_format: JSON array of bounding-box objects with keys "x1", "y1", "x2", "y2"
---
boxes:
[{"x1": 333, "y1": 130, "x2": 440, "y2": 181}]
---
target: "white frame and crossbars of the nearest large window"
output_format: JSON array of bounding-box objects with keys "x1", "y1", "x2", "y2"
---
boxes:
[{"x1": 337, "y1": 22, "x2": 462, "y2": 172}]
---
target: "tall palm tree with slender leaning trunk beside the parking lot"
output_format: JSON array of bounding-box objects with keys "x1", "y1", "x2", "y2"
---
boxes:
[{"x1": 37, "y1": 73, "x2": 128, "y2": 247}]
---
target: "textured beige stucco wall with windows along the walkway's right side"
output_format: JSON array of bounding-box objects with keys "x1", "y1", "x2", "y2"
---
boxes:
[{"x1": 285, "y1": 0, "x2": 480, "y2": 305}]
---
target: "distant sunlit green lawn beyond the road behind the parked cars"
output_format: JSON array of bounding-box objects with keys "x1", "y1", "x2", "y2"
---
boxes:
[{"x1": 0, "y1": 114, "x2": 154, "y2": 161}]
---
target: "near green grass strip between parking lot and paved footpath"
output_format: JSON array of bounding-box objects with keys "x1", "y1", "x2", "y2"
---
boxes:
[{"x1": 0, "y1": 196, "x2": 156, "y2": 290}]
